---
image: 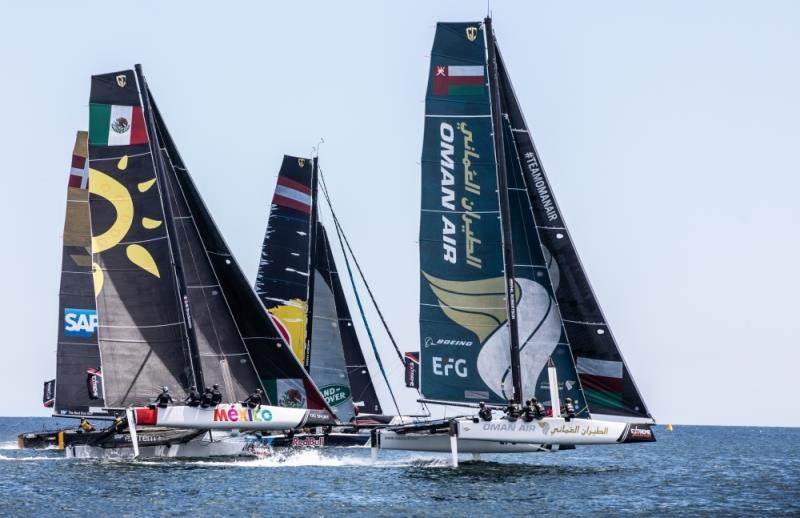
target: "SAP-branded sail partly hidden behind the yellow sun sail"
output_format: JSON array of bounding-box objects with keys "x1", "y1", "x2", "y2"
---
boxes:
[{"x1": 55, "y1": 131, "x2": 105, "y2": 414}]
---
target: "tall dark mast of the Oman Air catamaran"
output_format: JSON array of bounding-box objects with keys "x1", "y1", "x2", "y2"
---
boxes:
[{"x1": 484, "y1": 16, "x2": 522, "y2": 403}]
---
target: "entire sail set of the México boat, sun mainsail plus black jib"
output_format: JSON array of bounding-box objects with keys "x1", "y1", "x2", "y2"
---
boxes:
[{"x1": 89, "y1": 68, "x2": 333, "y2": 422}]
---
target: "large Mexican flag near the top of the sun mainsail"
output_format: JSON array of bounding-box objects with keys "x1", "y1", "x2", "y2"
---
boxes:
[{"x1": 89, "y1": 103, "x2": 147, "y2": 146}]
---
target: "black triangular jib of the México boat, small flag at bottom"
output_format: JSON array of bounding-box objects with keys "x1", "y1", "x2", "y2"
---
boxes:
[{"x1": 154, "y1": 95, "x2": 333, "y2": 421}]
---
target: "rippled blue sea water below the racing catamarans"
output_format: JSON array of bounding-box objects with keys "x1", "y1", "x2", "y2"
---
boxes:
[{"x1": 0, "y1": 417, "x2": 800, "y2": 517}]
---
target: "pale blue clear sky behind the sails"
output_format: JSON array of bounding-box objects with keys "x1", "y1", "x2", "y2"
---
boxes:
[{"x1": 0, "y1": 0, "x2": 800, "y2": 426}]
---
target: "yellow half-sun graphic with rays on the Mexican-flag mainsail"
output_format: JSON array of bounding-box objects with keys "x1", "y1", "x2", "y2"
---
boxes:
[{"x1": 89, "y1": 155, "x2": 162, "y2": 296}]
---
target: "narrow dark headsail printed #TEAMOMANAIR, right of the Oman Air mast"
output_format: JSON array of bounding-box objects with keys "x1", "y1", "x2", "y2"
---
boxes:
[{"x1": 497, "y1": 49, "x2": 651, "y2": 419}]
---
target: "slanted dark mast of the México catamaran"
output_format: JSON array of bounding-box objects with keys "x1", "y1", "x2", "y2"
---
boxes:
[{"x1": 134, "y1": 63, "x2": 205, "y2": 387}]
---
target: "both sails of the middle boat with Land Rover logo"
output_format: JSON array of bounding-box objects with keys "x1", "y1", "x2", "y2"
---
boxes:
[{"x1": 256, "y1": 155, "x2": 381, "y2": 422}]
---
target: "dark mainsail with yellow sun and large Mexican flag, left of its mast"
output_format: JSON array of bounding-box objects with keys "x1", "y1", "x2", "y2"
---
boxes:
[{"x1": 89, "y1": 70, "x2": 194, "y2": 407}]
